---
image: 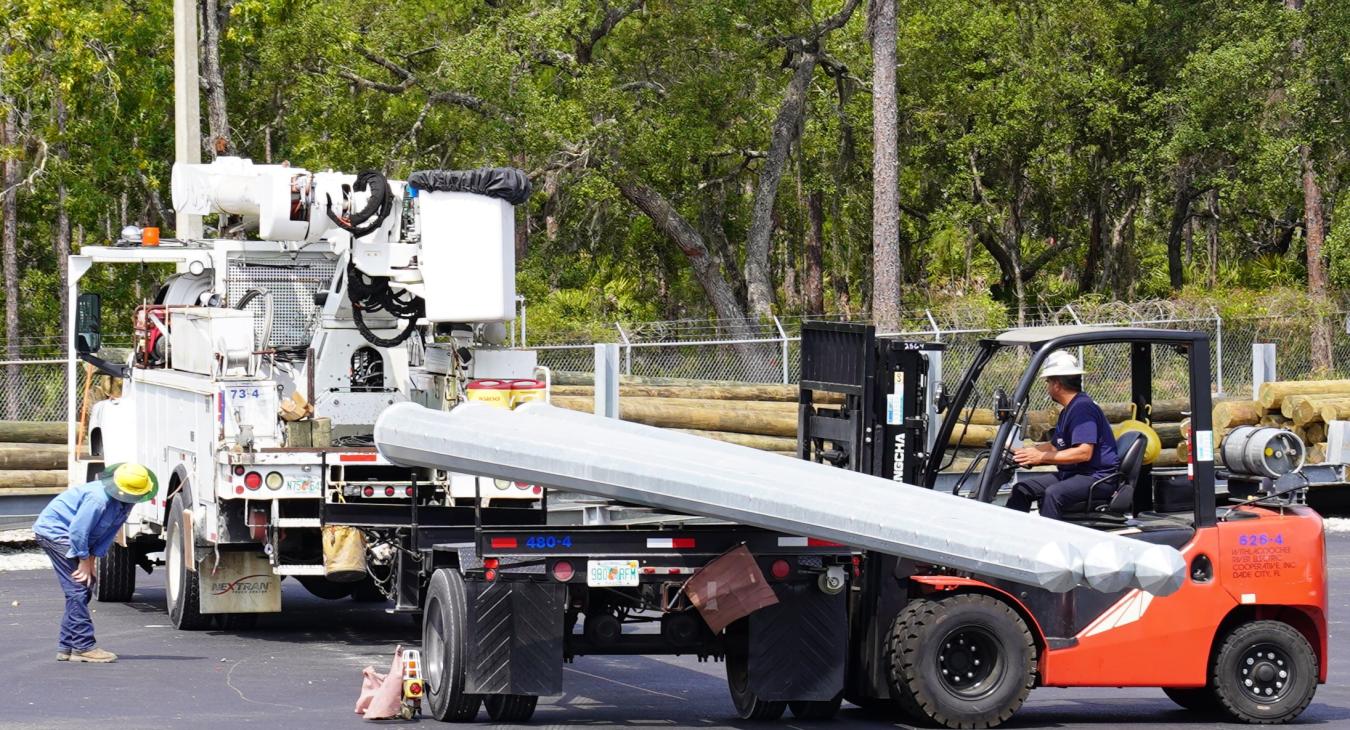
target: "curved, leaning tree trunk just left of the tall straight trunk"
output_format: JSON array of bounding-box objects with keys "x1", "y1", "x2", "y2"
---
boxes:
[{"x1": 745, "y1": 51, "x2": 817, "y2": 318}]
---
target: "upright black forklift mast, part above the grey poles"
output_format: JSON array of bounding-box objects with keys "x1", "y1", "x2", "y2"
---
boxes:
[{"x1": 797, "y1": 322, "x2": 944, "y2": 484}]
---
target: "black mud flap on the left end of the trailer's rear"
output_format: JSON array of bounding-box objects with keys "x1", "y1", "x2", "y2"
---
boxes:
[{"x1": 464, "y1": 580, "x2": 566, "y2": 696}]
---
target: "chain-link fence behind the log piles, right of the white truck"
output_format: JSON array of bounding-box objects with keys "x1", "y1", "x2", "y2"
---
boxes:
[{"x1": 529, "y1": 305, "x2": 1350, "y2": 401}]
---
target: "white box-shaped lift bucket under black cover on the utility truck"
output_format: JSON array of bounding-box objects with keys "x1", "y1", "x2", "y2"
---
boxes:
[{"x1": 417, "y1": 192, "x2": 516, "y2": 322}]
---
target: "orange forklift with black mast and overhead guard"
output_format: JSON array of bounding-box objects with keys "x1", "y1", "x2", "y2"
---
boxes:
[{"x1": 799, "y1": 322, "x2": 1327, "y2": 727}]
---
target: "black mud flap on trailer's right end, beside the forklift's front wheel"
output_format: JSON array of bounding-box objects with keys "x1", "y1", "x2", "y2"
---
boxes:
[{"x1": 749, "y1": 584, "x2": 848, "y2": 702}]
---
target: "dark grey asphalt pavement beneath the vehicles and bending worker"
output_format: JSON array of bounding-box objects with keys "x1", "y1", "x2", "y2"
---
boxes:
[{"x1": 0, "y1": 533, "x2": 1350, "y2": 730}]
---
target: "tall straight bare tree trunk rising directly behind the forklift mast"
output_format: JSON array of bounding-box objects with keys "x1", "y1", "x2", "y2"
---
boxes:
[{"x1": 872, "y1": 0, "x2": 900, "y2": 332}]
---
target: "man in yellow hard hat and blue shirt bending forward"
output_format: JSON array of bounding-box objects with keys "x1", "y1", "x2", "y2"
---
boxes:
[{"x1": 32, "y1": 464, "x2": 159, "y2": 664}]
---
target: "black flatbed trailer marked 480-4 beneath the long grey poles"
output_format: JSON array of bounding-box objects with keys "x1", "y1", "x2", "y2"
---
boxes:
[{"x1": 323, "y1": 491, "x2": 855, "y2": 722}]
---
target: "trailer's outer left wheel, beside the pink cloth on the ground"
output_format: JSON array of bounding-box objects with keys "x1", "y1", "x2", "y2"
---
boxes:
[{"x1": 423, "y1": 568, "x2": 483, "y2": 722}]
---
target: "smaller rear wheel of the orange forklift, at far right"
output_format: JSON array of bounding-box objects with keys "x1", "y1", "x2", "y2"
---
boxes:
[{"x1": 1210, "y1": 621, "x2": 1318, "y2": 725}]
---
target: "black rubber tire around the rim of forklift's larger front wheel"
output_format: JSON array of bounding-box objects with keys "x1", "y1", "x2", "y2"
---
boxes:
[{"x1": 887, "y1": 594, "x2": 1035, "y2": 729}]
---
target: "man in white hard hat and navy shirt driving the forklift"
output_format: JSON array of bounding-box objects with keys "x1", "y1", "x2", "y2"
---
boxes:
[{"x1": 1007, "y1": 351, "x2": 1121, "y2": 520}]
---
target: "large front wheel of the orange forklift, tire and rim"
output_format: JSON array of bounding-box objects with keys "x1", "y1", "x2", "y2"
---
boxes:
[{"x1": 888, "y1": 594, "x2": 1035, "y2": 727}]
